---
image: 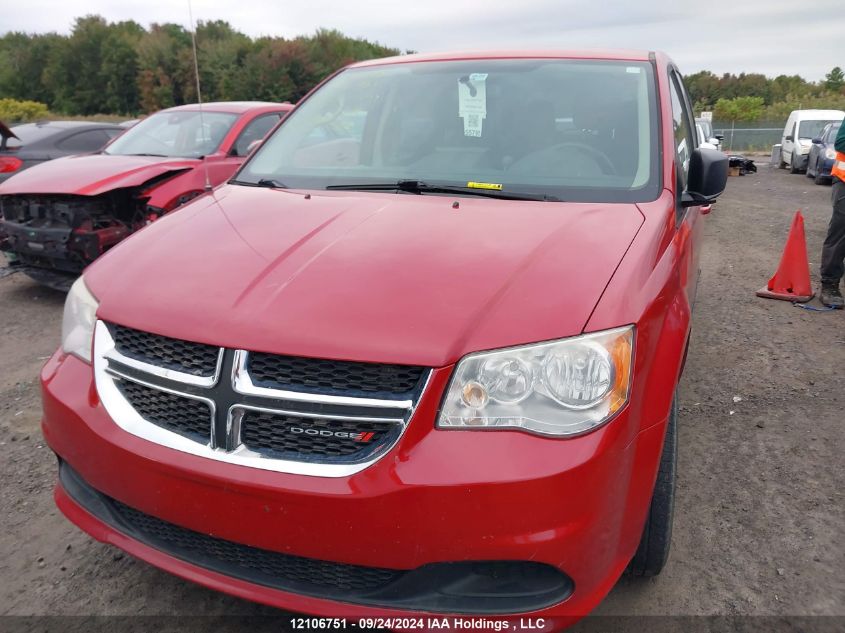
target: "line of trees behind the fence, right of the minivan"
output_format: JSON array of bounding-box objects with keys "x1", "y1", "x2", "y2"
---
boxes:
[{"x1": 684, "y1": 66, "x2": 845, "y2": 121}]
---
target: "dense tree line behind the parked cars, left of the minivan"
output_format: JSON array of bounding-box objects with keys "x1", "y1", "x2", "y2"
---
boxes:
[{"x1": 0, "y1": 15, "x2": 399, "y2": 115}]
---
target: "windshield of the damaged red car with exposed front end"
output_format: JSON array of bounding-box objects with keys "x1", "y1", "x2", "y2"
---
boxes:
[{"x1": 105, "y1": 110, "x2": 238, "y2": 158}]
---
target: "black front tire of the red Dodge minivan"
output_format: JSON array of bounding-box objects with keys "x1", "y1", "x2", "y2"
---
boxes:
[{"x1": 625, "y1": 397, "x2": 678, "y2": 577}]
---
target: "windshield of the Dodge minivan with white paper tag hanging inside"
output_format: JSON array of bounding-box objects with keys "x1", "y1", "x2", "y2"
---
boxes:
[{"x1": 233, "y1": 59, "x2": 658, "y2": 202}]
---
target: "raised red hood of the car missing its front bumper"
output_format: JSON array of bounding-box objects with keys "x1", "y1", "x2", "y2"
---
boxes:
[{"x1": 0, "y1": 154, "x2": 202, "y2": 196}]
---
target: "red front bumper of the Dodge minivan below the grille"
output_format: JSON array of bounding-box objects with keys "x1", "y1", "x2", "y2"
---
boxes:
[{"x1": 42, "y1": 353, "x2": 665, "y2": 618}]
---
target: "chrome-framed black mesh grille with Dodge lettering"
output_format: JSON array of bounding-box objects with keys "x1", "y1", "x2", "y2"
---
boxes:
[{"x1": 94, "y1": 321, "x2": 431, "y2": 477}]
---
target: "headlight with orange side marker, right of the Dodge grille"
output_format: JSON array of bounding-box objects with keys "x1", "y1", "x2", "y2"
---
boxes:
[{"x1": 437, "y1": 326, "x2": 634, "y2": 435}]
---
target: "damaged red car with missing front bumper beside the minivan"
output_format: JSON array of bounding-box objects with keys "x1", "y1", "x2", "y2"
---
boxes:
[{"x1": 0, "y1": 102, "x2": 293, "y2": 290}]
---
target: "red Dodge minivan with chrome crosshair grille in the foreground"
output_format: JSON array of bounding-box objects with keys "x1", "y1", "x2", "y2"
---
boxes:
[{"x1": 41, "y1": 52, "x2": 727, "y2": 619}]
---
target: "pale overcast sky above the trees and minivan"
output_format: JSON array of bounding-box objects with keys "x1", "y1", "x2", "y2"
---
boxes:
[{"x1": 0, "y1": 0, "x2": 845, "y2": 81}]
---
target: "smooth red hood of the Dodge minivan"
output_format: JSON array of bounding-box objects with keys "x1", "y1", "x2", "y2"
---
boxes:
[{"x1": 85, "y1": 185, "x2": 643, "y2": 366}]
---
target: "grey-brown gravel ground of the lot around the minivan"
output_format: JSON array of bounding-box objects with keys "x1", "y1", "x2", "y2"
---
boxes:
[{"x1": 0, "y1": 159, "x2": 845, "y2": 631}]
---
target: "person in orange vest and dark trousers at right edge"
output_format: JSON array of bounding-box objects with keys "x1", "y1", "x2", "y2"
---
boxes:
[{"x1": 820, "y1": 119, "x2": 845, "y2": 310}]
